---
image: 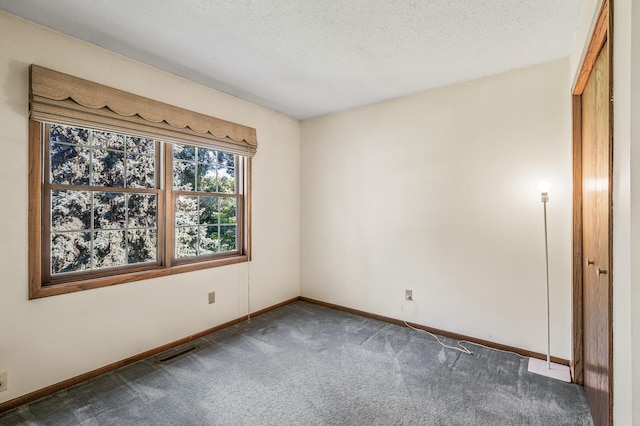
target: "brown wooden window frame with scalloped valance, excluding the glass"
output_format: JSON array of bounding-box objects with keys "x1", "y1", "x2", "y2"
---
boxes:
[{"x1": 28, "y1": 66, "x2": 257, "y2": 299}]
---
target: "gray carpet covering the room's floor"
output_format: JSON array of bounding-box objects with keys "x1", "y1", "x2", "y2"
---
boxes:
[{"x1": 0, "y1": 302, "x2": 592, "y2": 426}]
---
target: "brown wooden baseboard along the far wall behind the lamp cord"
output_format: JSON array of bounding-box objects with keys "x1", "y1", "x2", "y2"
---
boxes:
[{"x1": 300, "y1": 296, "x2": 569, "y2": 365}]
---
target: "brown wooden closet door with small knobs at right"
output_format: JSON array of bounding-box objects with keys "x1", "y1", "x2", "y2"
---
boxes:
[{"x1": 582, "y1": 42, "x2": 612, "y2": 425}]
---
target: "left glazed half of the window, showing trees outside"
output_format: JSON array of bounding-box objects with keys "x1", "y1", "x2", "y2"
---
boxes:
[{"x1": 49, "y1": 125, "x2": 158, "y2": 275}]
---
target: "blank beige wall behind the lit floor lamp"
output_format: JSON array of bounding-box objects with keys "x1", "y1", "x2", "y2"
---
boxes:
[{"x1": 301, "y1": 59, "x2": 571, "y2": 358}]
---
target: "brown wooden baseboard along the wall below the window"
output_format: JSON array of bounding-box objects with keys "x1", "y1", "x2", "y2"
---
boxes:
[{"x1": 0, "y1": 297, "x2": 299, "y2": 413}]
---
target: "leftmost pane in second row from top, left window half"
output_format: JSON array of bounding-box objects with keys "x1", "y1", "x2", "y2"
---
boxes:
[{"x1": 50, "y1": 143, "x2": 91, "y2": 185}]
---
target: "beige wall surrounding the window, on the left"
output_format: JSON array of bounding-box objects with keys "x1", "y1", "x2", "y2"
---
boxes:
[{"x1": 0, "y1": 12, "x2": 300, "y2": 402}]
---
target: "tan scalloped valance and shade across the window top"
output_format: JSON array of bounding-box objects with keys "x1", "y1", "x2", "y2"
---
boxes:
[{"x1": 29, "y1": 65, "x2": 258, "y2": 157}]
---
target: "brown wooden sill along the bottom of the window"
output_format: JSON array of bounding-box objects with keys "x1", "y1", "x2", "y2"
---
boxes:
[{"x1": 29, "y1": 255, "x2": 249, "y2": 299}]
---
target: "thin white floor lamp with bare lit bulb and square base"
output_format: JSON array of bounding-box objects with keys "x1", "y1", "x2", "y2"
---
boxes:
[{"x1": 528, "y1": 181, "x2": 571, "y2": 382}]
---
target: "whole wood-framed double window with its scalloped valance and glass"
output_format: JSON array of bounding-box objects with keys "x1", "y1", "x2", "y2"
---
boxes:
[{"x1": 29, "y1": 66, "x2": 256, "y2": 298}]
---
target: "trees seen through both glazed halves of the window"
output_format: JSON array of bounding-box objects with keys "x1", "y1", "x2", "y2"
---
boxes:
[{"x1": 45, "y1": 124, "x2": 240, "y2": 276}]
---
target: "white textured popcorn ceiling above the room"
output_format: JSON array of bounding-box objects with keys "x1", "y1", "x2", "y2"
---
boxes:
[{"x1": 0, "y1": 0, "x2": 583, "y2": 119}]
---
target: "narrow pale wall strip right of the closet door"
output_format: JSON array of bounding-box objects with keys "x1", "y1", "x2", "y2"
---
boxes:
[{"x1": 613, "y1": 0, "x2": 640, "y2": 425}]
